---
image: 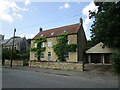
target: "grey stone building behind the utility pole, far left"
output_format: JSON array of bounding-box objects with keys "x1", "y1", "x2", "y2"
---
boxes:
[{"x1": 2, "y1": 36, "x2": 28, "y2": 53}]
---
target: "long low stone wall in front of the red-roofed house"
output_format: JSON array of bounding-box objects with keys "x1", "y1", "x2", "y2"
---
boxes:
[{"x1": 29, "y1": 61, "x2": 83, "y2": 71}]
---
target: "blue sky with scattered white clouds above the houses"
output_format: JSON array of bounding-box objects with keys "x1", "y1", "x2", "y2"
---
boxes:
[{"x1": 0, "y1": 0, "x2": 97, "y2": 39}]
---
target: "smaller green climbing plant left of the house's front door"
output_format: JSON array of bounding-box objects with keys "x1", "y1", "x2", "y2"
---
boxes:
[{"x1": 30, "y1": 37, "x2": 47, "y2": 61}]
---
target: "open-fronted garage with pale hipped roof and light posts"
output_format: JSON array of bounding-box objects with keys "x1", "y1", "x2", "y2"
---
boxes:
[{"x1": 86, "y1": 42, "x2": 113, "y2": 64}]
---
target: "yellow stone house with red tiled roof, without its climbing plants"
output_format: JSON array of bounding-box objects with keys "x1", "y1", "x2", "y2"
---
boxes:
[{"x1": 30, "y1": 18, "x2": 87, "y2": 62}]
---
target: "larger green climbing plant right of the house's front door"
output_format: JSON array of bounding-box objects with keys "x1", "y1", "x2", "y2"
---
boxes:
[{"x1": 53, "y1": 32, "x2": 77, "y2": 62}]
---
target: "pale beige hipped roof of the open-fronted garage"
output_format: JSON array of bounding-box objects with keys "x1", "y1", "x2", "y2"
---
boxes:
[{"x1": 86, "y1": 42, "x2": 113, "y2": 53}]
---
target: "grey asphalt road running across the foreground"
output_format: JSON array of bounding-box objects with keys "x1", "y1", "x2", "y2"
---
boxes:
[{"x1": 2, "y1": 68, "x2": 118, "y2": 88}]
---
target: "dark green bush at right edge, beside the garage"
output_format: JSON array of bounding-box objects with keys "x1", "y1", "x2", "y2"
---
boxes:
[{"x1": 110, "y1": 49, "x2": 120, "y2": 75}]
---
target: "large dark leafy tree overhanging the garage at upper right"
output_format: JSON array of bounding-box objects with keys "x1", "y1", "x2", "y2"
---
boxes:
[{"x1": 89, "y1": 1, "x2": 120, "y2": 48}]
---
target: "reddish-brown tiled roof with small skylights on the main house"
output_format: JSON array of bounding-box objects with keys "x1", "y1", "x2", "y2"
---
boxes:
[{"x1": 33, "y1": 23, "x2": 80, "y2": 39}]
